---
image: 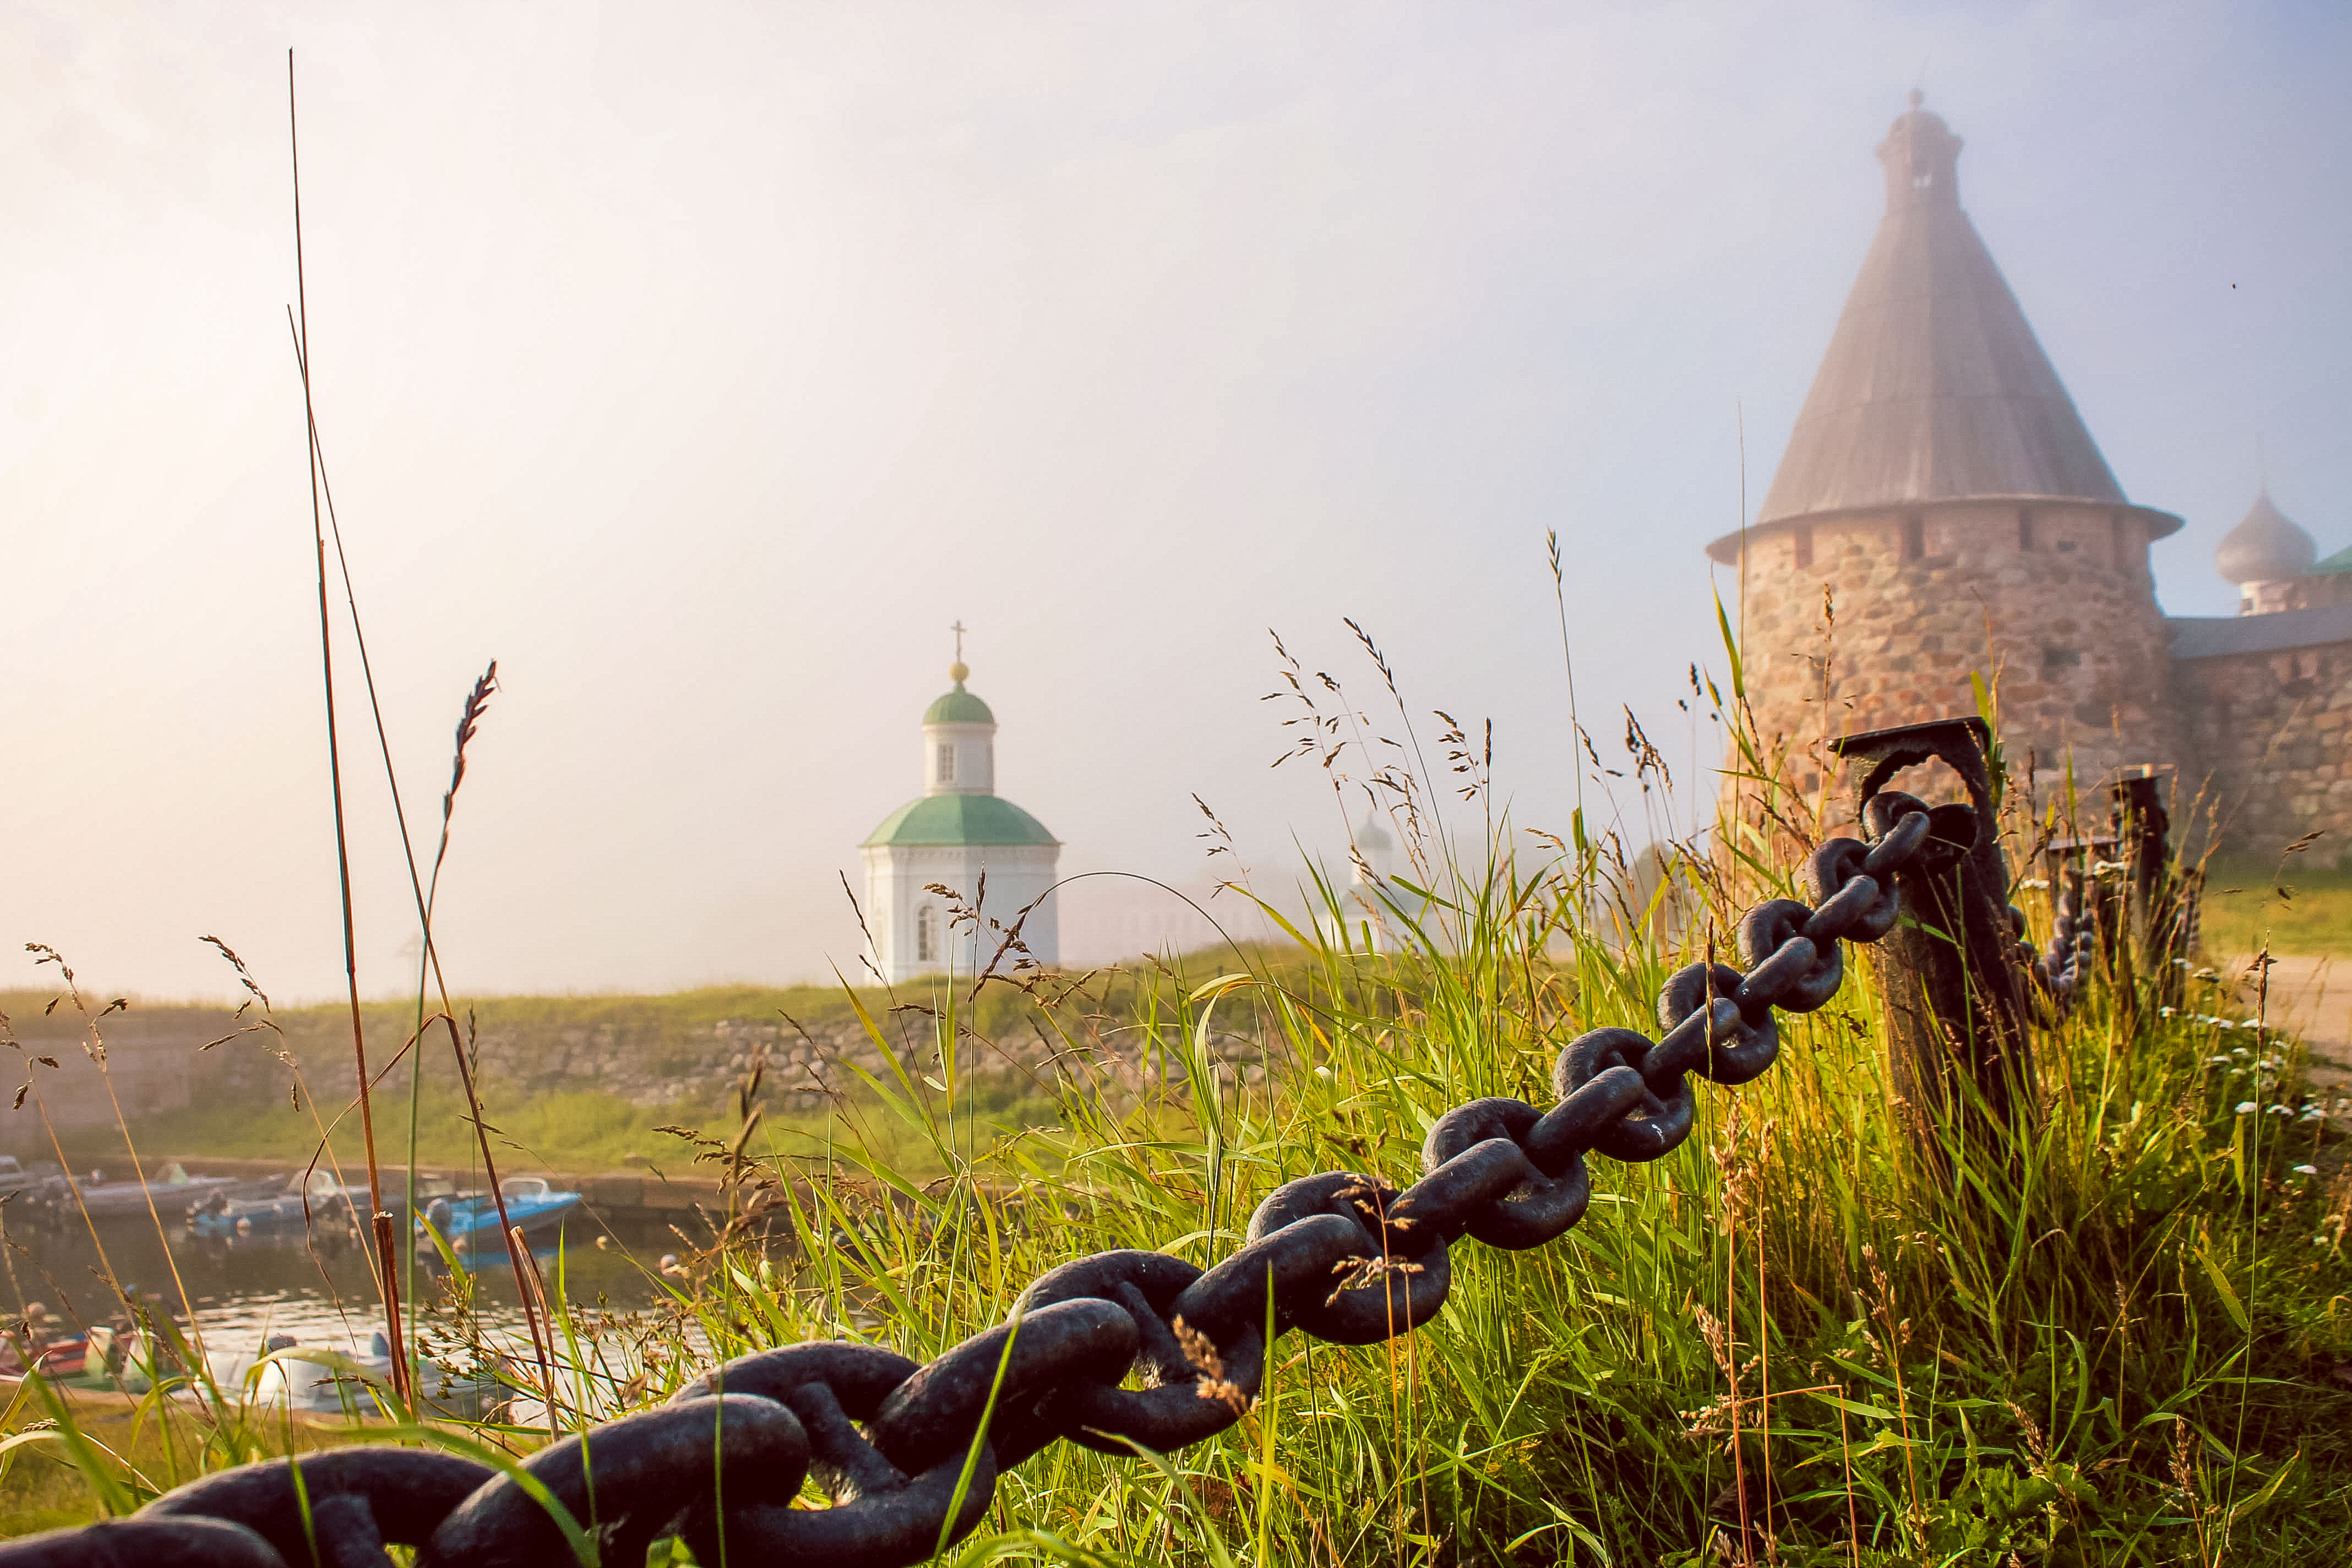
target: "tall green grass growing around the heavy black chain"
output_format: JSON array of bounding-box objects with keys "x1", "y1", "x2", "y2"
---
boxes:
[{"x1": 654, "y1": 860, "x2": 2352, "y2": 1563}]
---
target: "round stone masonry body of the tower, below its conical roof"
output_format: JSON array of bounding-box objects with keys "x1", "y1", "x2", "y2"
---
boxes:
[{"x1": 1743, "y1": 500, "x2": 2182, "y2": 790}]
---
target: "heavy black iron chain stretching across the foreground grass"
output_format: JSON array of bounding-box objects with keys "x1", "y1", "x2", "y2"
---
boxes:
[{"x1": 0, "y1": 792, "x2": 1947, "y2": 1568}]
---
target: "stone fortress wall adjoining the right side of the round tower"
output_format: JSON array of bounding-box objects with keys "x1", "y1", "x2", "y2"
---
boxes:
[{"x1": 2173, "y1": 642, "x2": 2352, "y2": 865}]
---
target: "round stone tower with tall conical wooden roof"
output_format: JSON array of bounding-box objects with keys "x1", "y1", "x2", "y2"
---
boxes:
[{"x1": 1707, "y1": 92, "x2": 2182, "y2": 792}]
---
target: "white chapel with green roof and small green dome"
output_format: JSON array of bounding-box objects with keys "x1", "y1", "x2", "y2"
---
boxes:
[{"x1": 861, "y1": 625, "x2": 1061, "y2": 985}]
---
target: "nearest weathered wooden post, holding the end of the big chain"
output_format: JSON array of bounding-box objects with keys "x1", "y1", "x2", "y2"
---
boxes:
[{"x1": 1830, "y1": 720, "x2": 2032, "y2": 1164}]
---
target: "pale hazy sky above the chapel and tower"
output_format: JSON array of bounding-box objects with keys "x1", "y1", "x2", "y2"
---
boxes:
[{"x1": 0, "y1": 0, "x2": 2352, "y2": 997}]
